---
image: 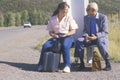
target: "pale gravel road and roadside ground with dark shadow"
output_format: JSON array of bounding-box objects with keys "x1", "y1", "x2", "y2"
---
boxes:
[{"x1": 0, "y1": 26, "x2": 120, "y2": 80}]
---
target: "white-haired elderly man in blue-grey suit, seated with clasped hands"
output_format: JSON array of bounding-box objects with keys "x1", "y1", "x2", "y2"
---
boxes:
[{"x1": 75, "y1": 2, "x2": 111, "y2": 71}]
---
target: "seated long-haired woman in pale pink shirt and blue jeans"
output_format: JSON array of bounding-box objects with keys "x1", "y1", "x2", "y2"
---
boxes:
[{"x1": 38, "y1": 2, "x2": 78, "y2": 72}]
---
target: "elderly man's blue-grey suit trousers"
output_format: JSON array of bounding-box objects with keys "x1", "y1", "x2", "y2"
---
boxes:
[{"x1": 74, "y1": 37, "x2": 110, "y2": 65}]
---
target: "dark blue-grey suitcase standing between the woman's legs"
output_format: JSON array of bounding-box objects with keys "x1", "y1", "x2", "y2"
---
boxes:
[{"x1": 43, "y1": 52, "x2": 60, "y2": 72}]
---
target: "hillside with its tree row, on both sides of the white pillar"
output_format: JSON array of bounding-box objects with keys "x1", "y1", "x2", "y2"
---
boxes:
[{"x1": 0, "y1": 0, "x2": 120, "y2": 26}]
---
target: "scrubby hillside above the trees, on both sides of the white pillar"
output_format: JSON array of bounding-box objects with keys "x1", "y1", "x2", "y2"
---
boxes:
[{"x1": 0, "y1": 0, "x2": 120, "y2": 14}]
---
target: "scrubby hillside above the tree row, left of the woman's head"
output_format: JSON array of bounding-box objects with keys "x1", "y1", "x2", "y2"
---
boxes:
[{"x1": 0, "y1": 0, "x2": 61, "y2": 13}]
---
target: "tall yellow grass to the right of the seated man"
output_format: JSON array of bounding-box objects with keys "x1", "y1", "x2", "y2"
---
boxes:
[{"x1": 108, "y1": 16, "x2": 120, "y2": 62}]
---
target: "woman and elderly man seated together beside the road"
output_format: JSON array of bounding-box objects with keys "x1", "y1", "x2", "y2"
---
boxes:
[{"x1": 38, "y1": 2, "x2": 111, "y2": 72}]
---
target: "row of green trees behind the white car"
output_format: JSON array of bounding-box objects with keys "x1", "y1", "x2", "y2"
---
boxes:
[{"x1": 0, "y1": 9, "x2": 49, "y2": 27}]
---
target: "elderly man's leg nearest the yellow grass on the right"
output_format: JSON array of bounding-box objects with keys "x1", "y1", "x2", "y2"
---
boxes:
[{"x1": 97, "y1": 38, "x2": 111, "y2": 71}]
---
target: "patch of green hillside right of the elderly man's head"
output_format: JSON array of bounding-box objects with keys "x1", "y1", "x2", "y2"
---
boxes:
[{"x1": 89, "y1": 0, "x2": 120, "y2": 14}]
